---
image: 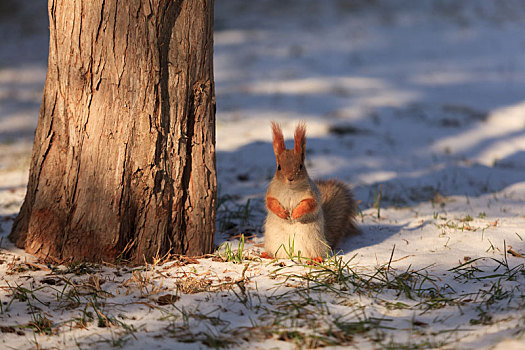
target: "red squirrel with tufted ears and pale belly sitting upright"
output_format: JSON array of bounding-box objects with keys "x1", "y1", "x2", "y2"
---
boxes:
[{"x1": 264, "y1": 122, "x2": 359, "y2": 260}]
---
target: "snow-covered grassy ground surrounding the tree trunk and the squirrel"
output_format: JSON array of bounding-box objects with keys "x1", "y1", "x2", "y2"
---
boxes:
[{"x1": 0, "y1": 0, "x2": 525, "y2": 350}]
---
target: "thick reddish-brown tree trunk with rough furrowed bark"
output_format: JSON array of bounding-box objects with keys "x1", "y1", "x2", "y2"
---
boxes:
[{"x1": 10, "y1": 0, "x2": 216, "y2": 263}]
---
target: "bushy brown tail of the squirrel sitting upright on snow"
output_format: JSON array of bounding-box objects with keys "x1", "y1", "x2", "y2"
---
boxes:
[{"x1": 316, "y1": 180, "x2": 359, "y2": 249}]
